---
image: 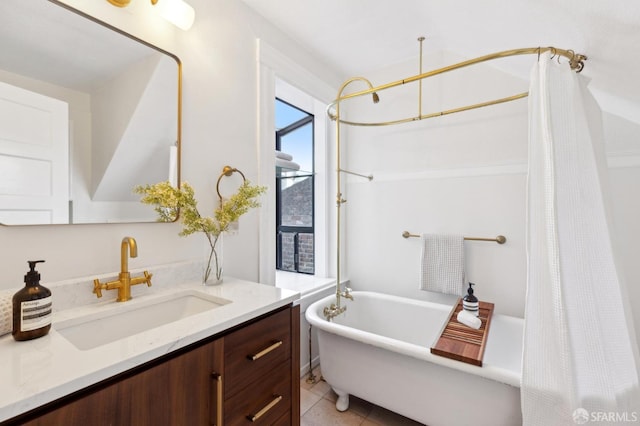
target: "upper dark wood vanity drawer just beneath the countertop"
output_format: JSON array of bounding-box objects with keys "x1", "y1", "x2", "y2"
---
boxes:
[{"x1": 224, "y1": 309, "x2": 291, "y2": 397}]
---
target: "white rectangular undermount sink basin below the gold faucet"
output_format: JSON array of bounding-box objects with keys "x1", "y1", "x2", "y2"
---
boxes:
[{"x1": 53, "y1": 290, "x2": 231, "y2": 351}]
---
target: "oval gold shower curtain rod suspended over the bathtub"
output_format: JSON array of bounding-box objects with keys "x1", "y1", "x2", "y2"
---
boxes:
[{"x1": 327, "y1": 46, "x2": 587, "y2": 126}]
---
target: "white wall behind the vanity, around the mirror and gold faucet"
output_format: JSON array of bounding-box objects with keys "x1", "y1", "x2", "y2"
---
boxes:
[{"x1": 0, "y1": 0, "x2": 339, "y2": 288}]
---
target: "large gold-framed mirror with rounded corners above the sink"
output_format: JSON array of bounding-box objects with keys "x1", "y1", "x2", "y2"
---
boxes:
[{"x1": 0, "y1": 0, "x2": 182, "y2": 225}]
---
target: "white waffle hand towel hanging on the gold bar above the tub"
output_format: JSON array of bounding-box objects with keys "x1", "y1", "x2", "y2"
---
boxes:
[{"x1": 420, "y1": 234, "x2": 464, "y2": 296}]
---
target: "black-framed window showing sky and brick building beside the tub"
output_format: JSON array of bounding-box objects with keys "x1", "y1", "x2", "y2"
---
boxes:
[{"x1": 275, "y1": 98, "x2": 315, "y2": 274}]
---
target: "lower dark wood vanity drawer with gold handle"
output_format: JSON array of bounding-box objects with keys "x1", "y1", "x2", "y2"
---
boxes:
[{"x1": 224, "y1": 362, "x2": 291, "y2": 426}]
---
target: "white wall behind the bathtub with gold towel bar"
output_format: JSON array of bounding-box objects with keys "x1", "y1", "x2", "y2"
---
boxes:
[{"x1": 342, "y1": 53, "x2": 640, "y2": 338}]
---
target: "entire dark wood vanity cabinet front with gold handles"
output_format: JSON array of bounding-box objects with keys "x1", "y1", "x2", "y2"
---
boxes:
[{"x1": 6, "y1": 306, "x2": 300, "y2": 426}]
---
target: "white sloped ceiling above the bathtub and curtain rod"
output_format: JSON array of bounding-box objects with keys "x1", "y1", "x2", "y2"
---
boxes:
[{"x1": 243, "y1": 0, "x2": 640, "y2": 122}]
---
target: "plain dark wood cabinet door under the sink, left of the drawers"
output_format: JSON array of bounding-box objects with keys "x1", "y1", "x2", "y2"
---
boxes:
[{"x1": 16, "y1": 339, "x2": 223, "y2": 426}]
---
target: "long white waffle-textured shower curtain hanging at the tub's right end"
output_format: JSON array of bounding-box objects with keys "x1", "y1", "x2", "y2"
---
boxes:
[{"x1": 521, "y1": 53, "x2": 640, "y2": 426}]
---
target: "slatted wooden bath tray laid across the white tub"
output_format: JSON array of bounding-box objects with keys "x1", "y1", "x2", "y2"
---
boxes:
[{"x1": 431, "y1": 299, "x2": 493, "y2": 367}]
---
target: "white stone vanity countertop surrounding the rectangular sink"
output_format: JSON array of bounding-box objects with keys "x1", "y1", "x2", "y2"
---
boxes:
[{"x1": 0, "y1": 277, "x2": 299, "y2": 422}]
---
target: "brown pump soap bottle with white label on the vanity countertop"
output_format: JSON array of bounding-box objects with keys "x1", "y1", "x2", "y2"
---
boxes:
[{"x1": 12, "y1": 260, "x2": 52, "y2": 340}]
